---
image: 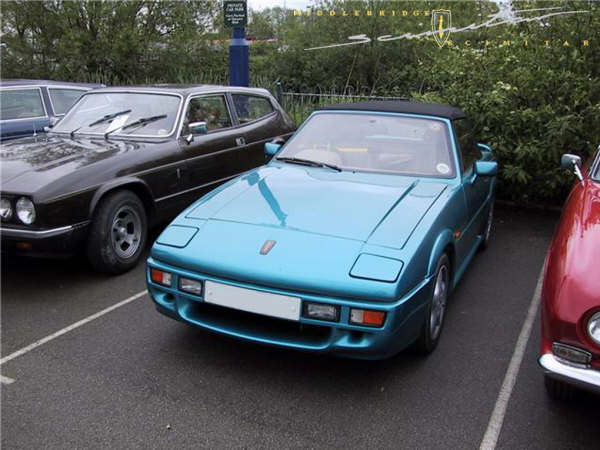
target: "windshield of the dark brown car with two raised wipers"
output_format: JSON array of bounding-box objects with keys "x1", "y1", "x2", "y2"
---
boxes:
[{"x1": 52, "y1": 92, "x2": 181, "y2": 137}]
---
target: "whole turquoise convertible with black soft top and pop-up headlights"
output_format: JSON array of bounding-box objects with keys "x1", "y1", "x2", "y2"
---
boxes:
[{"x1": 147, "y1": 101, "x2": 497, "y2": 359}]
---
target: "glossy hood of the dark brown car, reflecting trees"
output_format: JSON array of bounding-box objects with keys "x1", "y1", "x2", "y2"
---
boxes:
[{"x1": 0, "y1": 135, "x2": 146, "y2": 194}]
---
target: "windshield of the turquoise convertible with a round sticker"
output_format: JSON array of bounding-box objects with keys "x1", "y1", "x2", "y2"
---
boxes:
[{"x1": 277, "y1": 112, "x2": 455, "y2": 178}]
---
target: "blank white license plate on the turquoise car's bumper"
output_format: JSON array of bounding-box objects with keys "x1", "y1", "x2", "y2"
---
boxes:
[{"x1": 204, "y1": 281, "x2": 300, "y2": 320}]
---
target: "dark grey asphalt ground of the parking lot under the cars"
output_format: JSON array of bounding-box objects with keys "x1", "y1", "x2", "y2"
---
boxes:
[{"x1": 0, "y1": 208, "x2": 600, "y2": 449}]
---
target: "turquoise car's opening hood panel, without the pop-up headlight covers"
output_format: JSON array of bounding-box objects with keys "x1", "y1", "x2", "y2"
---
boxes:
[{"x1": 186, "y1": 165, "x2": 446, "y2": 247}]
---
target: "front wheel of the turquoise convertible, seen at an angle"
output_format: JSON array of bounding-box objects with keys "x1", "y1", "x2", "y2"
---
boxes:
[{"x1": 413, "y1": 253, "x2": 452, "y2": 355}]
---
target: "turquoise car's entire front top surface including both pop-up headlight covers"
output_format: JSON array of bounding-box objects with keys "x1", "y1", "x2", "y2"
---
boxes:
[{"x1": 152, "y1": 165, "x2": 446, "y2": 301}]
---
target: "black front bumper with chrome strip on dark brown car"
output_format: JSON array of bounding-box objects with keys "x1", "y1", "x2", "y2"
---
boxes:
[{"x1": 0, "y1": 222, "x2": 89, "y2": 256}]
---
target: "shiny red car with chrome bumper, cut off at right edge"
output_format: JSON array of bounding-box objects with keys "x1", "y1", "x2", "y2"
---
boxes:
[{"x1": 539, "y1": 147, "x2": 600, "y2": 399}]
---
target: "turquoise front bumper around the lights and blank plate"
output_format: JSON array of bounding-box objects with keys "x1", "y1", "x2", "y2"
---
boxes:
[{"x1": 146, "y1": 258, "x2": 432, "y2": 359}]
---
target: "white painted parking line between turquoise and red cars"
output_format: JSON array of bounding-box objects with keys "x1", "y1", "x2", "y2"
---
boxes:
[{"x1": 479, "y1": 261, "x2": 546, "y2": 450}]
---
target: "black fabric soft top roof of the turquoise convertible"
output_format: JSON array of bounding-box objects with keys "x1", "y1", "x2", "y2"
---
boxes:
[{"x1": 319, "y1": 100, "x2": 467, "y2": 119}]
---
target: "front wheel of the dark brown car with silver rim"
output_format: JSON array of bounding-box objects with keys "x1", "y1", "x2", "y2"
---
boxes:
[{"x1": 87, "y1": 191, "x2": 148, "y2": 275}]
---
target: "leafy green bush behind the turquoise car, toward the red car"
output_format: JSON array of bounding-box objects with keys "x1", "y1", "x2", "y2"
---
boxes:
[{"x1": 413, "y1": 40, "x2": 600, "y2": 204}]
